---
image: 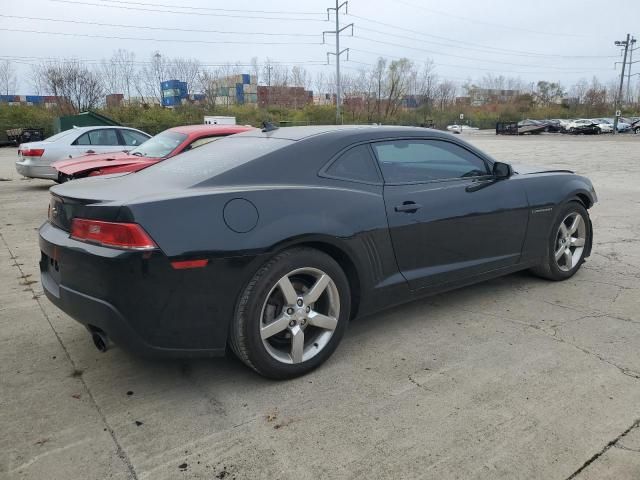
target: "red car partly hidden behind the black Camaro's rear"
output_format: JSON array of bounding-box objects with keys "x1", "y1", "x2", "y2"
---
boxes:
[{"x1": 51, "y1": 125, "x2": 252, "y2": 182}]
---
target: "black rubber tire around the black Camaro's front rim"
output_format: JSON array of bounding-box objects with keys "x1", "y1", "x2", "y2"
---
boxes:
[{"x1": 531, "y1": 200, "x2": 593, "y2": 281}]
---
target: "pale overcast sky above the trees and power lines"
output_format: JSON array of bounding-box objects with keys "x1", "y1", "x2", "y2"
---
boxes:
[{"x1": 0, "y1": 0, "x2": 640, "y2": 94}]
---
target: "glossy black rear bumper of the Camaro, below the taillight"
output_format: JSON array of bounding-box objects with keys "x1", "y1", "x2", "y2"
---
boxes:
[{"x1": 40, "y1": 222, "x2": 256, "y2": 357}]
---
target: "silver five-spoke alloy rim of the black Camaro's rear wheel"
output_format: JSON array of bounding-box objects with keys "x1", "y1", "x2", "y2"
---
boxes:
[{"x1": 260, "y1": 267, "x2": 340, "y2": 364}]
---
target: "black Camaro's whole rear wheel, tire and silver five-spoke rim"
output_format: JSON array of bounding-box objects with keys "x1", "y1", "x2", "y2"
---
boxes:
[{"x1": 229, "y1": 248, "x2": 350, "y2": 379}]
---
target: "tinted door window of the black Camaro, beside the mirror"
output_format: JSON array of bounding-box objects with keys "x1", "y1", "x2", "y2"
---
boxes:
[{"x1": 373, "y1": 140, "x2": 489, "y2": 183}]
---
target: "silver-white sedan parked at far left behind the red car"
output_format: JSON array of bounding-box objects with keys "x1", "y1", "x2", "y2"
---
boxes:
[{"x1": 16, "y1": 126, "x2": 151, "y2": 180}]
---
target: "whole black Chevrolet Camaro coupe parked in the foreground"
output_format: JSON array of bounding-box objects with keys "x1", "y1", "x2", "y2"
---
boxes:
[{"x1": 40, "y1": 126, "x2": 596, "y2": 378}]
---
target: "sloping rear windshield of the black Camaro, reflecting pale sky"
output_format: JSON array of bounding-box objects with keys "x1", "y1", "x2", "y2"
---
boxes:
[{"x1": 149, "y1": 136, "x2": 293, "y2": 181}]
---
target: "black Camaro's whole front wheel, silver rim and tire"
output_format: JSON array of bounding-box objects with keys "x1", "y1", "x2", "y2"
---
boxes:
[{"x1": 532, "y1": 202, "x2": 592, "y2": 280}]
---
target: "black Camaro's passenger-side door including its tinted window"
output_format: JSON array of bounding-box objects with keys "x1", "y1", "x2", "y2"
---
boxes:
[{"x1": 372, "y1": 139, "x2": 528, "y2": 290}]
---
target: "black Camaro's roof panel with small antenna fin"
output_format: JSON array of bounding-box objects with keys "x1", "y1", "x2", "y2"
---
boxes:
[{"x1": 232, "y1": 125, "x2": 442, "y2": 141}]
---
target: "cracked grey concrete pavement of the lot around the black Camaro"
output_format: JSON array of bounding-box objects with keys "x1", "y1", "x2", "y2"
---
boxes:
[{"x1": 0, "y1": 135, "x2": 640, "y2": 480}]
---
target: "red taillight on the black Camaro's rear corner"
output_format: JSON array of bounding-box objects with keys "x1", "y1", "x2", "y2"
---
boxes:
[{"x1": 71, "y1": 218, "x2": 158, "y2": 250}]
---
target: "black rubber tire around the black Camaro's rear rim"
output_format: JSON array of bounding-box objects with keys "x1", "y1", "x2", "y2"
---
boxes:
[{"x1": 229, "y1": 247, "x2": 351, "y2": 379}]
